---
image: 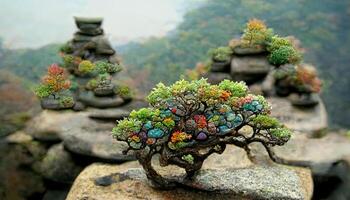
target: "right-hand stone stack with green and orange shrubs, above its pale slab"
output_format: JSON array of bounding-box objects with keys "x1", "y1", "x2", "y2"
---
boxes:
[{"x1": 202, "y1": 19, "x2": 321, "y2": 106}]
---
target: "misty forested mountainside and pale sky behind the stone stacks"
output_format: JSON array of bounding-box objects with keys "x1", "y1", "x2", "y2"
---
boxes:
[{"x1": 0, "y1": 0, "x2": 350, "y2": 136}]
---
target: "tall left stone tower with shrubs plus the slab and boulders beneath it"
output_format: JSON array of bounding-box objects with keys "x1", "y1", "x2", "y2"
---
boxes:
[{"x1": 0, "y1": 17, "x2": 148, "y2": 200}]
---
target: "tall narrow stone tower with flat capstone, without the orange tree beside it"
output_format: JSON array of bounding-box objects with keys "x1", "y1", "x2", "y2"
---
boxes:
[{"x1": 61, "y1": 17, "x2": 137, "y2": 119}]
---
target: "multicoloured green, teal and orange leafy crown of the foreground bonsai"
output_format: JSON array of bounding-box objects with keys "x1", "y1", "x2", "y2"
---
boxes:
[{"x1": 113, "y1": 79, "x2": 289, "y2": 150}]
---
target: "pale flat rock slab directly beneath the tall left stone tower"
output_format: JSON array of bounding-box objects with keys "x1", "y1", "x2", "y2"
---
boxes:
[{"x1": 26, "y1": 110, "x2": 134, "y2": 162}]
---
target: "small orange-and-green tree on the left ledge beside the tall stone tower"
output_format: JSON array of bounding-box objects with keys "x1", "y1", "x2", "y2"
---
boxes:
[{"x1": 35, "y1": 64, "x2": 74, "y2": 109}]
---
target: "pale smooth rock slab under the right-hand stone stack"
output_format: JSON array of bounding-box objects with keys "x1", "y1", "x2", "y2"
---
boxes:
[{"x1": 267, "y1": 97, "x2": 328, "y2": 136}]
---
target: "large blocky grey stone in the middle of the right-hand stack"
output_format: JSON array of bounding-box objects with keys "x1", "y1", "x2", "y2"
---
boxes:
[{"x1": 231, "y1": 56, "x2": 273, "y2": 84}]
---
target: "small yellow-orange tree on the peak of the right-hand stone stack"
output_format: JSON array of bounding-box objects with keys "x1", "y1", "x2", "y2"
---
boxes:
[{"x1": 241, "y1": 19, "x2": 273, "y2": 47}]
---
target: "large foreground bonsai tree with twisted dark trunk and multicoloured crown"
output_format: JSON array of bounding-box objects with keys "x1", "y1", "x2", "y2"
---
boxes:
[{"x1": 112, "y1": 79, "x2": 291, "y2": 188}]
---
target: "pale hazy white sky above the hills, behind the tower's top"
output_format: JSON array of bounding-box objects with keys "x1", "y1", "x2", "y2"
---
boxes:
[{"x1": 0, "y1": 0, "x2": 194, "y2": 48}]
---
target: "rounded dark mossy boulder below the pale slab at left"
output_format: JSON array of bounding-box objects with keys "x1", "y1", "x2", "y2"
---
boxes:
[{"x1": 38, "y1": 144, "x2": 83, "y2": 183}]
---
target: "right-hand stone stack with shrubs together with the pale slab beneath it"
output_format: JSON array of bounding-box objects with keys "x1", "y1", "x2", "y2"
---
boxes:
[{"x1": 204, "y1": 19, "x2": 327, "y2": 133}]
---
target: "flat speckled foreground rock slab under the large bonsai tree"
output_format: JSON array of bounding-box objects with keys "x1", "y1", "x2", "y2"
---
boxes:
[{"x1": 67, "y1": 162, "x2": 312, "y2": 200}]
